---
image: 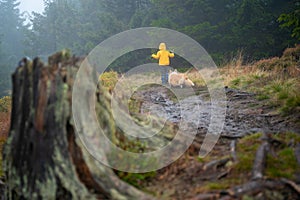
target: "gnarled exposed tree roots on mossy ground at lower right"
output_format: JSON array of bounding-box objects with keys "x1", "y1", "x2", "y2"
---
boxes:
[{"x1": 192, "y1": 134, "x2": 300, "y2": 200}]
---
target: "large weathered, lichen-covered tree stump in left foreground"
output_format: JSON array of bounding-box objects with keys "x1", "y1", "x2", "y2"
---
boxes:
[{"x1": 4, "y1": 51, "x2": 152, "y2": 200}]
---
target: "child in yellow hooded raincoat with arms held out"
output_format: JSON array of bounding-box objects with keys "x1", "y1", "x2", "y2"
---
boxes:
[{"x1": 152, "y1": 43, "x2": 174, "y2": 84}]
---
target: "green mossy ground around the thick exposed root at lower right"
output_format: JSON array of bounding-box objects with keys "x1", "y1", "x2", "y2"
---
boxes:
[{"x1": 210, "y1": 132, "x2": 300, "y2": 192}]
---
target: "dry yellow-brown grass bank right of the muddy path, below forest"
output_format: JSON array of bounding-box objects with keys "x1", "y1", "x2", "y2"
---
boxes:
[{"x1": 220, "y1": 45, "x2": 300, "y2": 114}]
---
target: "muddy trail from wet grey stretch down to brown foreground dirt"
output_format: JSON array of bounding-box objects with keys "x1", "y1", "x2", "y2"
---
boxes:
[{"x1": 132, "y1": 87, "x2": 300, "y2": 199}]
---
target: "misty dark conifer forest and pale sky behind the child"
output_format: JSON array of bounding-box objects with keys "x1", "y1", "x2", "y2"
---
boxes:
[{"x1": 0, "y1": 0, "x2": 300, "y2": 96}]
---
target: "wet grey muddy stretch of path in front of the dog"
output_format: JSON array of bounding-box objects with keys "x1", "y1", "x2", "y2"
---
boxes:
[{"x1": 135, "y1": 87, "x2": 299, "y2": 137}]
